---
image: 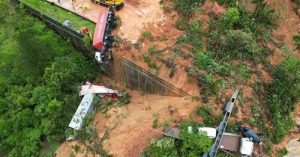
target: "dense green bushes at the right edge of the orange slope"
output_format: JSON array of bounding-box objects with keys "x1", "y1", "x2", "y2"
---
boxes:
[{"x1": 266, "y1": 57, "x2": 300, "y2": 143}]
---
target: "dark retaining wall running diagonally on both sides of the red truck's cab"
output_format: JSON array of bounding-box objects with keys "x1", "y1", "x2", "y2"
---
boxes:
[{"x1": 17, "y1": 1, "x2": 189, "y2": 96}]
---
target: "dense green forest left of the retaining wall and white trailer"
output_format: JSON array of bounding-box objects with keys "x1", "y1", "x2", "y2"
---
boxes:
[{"x1": 0, "y1": 0, "x2": 96, "y2": 157}]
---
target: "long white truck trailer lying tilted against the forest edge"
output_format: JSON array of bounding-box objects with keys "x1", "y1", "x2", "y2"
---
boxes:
[{"x1": 69, "y1": 93, "x2": 94, "y2": 130}]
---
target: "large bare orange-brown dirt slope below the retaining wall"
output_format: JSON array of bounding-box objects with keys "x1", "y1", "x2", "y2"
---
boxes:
[{"x1": 101, "y1": 91, "x2": 197, "y2": 157}]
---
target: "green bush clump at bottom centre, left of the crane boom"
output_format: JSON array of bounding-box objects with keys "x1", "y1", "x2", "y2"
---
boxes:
[{"x1": 140, "y1": 121, "x2": 212, "y2": 157}]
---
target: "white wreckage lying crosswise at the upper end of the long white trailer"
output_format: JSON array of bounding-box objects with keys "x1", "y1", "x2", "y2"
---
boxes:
[{"x1": 79, "y1": 84, "x2": 119, "y2": 96}]
